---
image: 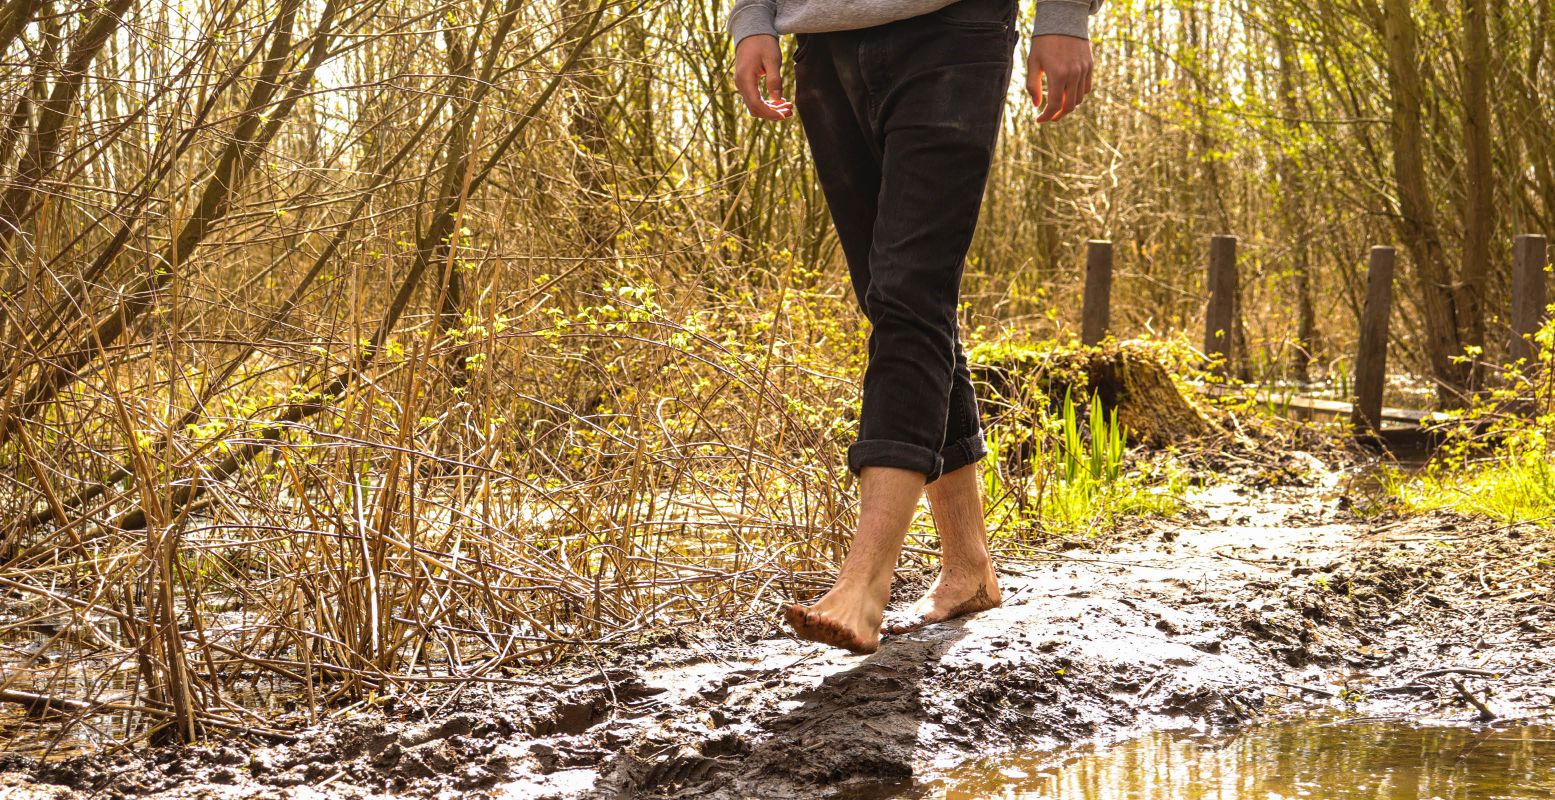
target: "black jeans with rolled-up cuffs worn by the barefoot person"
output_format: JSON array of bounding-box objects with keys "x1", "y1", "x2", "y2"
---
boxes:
[{"x1": 793, "y1": 0, "x2": 1017, "y2": 481}]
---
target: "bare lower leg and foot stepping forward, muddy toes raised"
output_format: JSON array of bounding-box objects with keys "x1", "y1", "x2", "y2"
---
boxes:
[{"x1": 784, "y1": 467, "x2": 924, "y2": 652}]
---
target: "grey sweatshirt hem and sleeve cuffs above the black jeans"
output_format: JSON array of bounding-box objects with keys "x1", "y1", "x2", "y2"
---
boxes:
[{"x1": 729, "y1": 0, "x2": 1101, "y2": 44}]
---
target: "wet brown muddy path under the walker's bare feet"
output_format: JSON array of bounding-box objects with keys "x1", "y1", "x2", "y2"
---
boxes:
[{"x1": 0, "y1": 454, "x2": 1555, "y2": 798}]
